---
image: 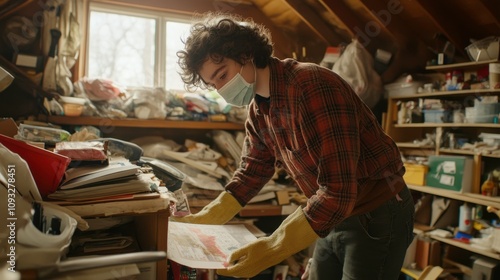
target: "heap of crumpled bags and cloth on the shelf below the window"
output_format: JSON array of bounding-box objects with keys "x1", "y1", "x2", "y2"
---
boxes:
[{"x1": 45, "y1": 78, "x2": 246, "y2": 122}]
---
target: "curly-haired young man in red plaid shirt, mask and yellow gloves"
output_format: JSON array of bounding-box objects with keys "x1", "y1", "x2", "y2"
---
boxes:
[{"x1": 177, "y1": 13, "x2": 414, "y2": 280}]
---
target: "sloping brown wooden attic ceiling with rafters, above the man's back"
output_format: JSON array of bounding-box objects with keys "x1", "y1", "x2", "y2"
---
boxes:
[{"x1": 246, "y1": 0, "x2": 500, "y2": 82}]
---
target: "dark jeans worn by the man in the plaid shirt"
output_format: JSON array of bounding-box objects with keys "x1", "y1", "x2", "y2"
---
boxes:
[{"x1": 309, "y1": 187, "x2": 415, "y2": 280}]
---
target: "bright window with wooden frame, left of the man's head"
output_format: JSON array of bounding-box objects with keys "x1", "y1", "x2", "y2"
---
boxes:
[{"x1": 86, "y1": 3, "x2": 190, "y2": 90}]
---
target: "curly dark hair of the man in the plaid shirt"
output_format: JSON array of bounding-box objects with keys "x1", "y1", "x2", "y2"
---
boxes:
[{"x1": 177, "y1": 12, "x2": 273, "y2": 91}]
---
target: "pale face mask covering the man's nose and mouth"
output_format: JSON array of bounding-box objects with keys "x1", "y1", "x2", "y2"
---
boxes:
[{"x1": 217, "y1": 62, "x2": 257, "y2": 106}]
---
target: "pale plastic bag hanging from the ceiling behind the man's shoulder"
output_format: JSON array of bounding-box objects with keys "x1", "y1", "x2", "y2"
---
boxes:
[{"x1": 332, "y1": 40, "x2": 383, "y2": 109}]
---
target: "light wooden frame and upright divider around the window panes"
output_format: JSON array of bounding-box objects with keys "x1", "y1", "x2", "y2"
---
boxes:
[{"x1": 86, "y1": 1, "x2": 192, "y2": 89}]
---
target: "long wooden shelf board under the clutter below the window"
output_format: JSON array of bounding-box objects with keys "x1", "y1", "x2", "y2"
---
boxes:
[{"x1": 38, "y1": 116, "x2": 245, "y2": 130}]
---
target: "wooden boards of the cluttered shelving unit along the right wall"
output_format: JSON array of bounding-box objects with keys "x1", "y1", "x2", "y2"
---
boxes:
[{"x1": 384, "y1": 61, "x2": 500, "y2": 276}]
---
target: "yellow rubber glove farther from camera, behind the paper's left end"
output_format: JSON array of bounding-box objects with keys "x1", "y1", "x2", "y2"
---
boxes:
[{"x1": 170, "y1": 191, "x2": 242, "y2": 225}]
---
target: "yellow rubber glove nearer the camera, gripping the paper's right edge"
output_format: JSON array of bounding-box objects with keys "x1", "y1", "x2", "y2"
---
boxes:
[{"x1": 217, "y1": 207, "x2": 318, "y2": 278}]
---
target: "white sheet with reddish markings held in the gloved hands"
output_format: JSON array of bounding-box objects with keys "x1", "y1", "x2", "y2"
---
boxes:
[{"x1": 167, "y1": 222, "x2": 256, "y2": 269}]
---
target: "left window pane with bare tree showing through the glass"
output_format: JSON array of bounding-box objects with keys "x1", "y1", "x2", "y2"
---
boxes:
[{"x1": 88, "y1": 12, "x2": 156, "y2": 86}]
